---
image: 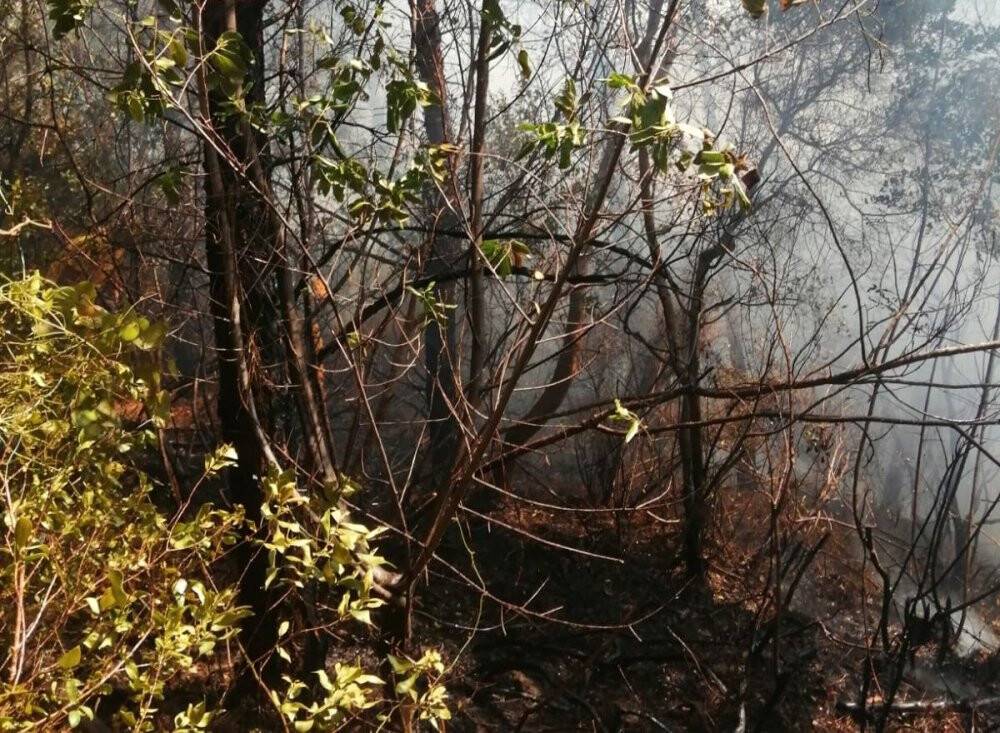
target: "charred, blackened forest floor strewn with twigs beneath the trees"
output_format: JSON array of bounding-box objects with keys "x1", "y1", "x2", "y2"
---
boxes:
[{"x1": 404, "y1": 486, "x2": 1000, "y2": 732}]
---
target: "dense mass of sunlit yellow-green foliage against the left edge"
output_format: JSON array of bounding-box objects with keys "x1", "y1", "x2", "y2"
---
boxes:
[{"x1": 0, "y1": 275, "x2": 244, "y2": 730}]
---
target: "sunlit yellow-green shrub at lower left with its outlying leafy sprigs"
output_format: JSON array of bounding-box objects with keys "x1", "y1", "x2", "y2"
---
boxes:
[{"x1": 0, "y1": 275, "x2": 449, "y2": 731}]
